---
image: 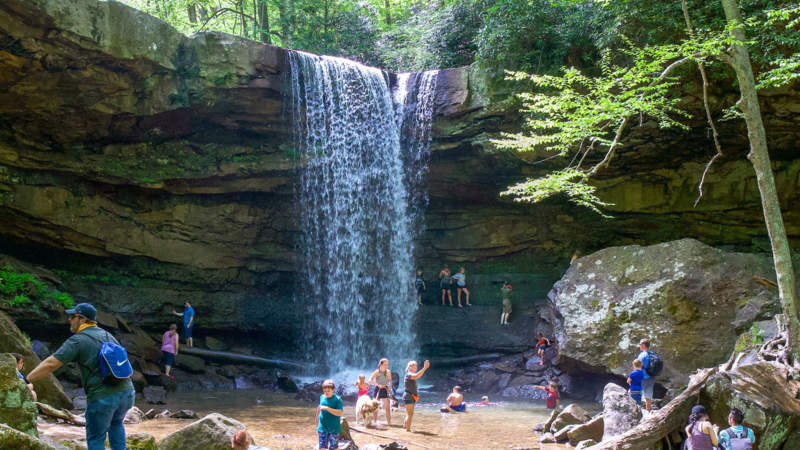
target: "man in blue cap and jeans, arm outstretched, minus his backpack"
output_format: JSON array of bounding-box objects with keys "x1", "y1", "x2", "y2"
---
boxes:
[{"x1": 28, "y1": 303, "x2": 135, "y2": 450}]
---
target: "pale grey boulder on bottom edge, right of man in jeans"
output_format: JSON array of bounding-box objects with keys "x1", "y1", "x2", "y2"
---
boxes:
[{"x1": 158, "y1": 413, "x2": 250, "y2": 450}]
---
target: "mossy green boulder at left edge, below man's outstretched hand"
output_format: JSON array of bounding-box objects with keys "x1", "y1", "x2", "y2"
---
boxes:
[{"x1": 0, "y1": 353, "x2": 39, "y2": 436}]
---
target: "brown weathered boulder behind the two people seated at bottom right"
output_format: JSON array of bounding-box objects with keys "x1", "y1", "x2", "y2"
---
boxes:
[{"x1": 700, "y1": 361, "x2": 800, "y2": 450}]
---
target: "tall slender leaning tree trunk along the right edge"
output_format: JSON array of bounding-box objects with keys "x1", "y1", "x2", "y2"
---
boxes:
[{"x1": 722, "y1": 0, "x2": 800, "y2": 361}]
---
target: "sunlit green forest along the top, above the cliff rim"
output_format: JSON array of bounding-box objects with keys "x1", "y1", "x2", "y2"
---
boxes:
[{"x1": 123, "y1": 0, "x2": 800, "y2": 74}]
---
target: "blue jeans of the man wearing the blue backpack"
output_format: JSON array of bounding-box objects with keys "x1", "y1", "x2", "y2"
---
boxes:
[{"x1": 86, "y1": 390, "x2": 136, "y2": 450}]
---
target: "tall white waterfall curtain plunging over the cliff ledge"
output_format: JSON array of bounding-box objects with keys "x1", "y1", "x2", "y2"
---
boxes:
[{"x1": 289, "y1": 52, "x2": 438, "y2": 372}]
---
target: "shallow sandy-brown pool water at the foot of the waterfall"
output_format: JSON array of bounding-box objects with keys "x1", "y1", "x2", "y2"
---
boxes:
[{"x1": 127, "y1": 390, "x2": 597, "y2": 450}]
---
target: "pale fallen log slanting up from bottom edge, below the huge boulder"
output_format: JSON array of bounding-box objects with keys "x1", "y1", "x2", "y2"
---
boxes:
[{"x1": 592, "y1": 364, "x2": 720, "y2": 450}]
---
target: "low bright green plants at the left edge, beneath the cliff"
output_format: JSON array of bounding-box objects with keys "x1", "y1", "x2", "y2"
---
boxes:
[{"x1": 0, "y1": 266, "x2": 75, "y2": 308}]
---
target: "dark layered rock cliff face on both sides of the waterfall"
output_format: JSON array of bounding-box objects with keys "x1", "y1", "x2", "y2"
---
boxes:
[{"x1": 0, "y1": 0, "x2": 800, "y2": 354}]
